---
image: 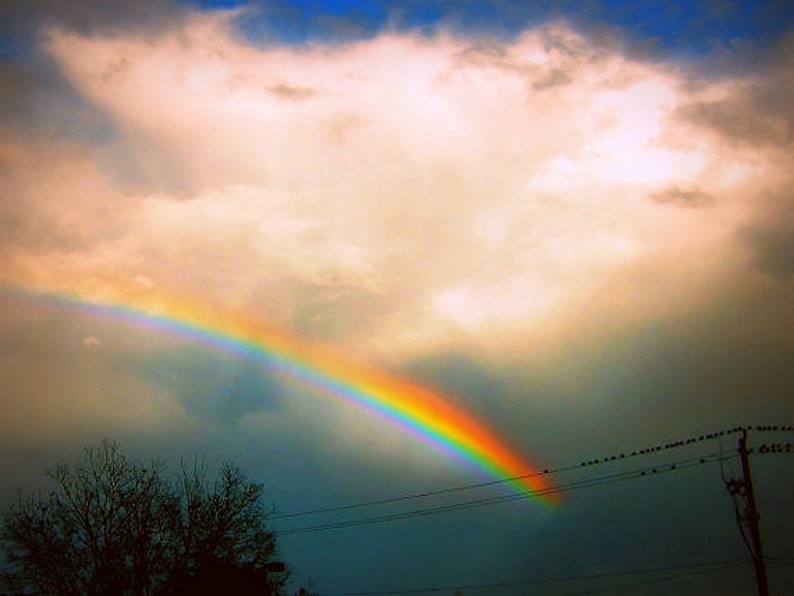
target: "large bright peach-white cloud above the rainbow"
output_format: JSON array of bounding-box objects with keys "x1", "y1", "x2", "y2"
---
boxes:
[{"x1": 3, "y1": 16, "x2": 776, "y2": 364}]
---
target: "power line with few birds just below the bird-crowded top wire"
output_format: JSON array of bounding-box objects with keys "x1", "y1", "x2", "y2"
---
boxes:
[{"x1": 279, "y1": 453, "x2": 736, "y2": 536}]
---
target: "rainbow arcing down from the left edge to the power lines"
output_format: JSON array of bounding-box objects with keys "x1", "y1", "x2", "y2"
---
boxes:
[{"x1": 4, "y1": 284, "x2": 558, "y2": 503}]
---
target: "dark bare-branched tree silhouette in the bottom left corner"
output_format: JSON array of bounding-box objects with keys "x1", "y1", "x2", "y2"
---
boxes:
[{"x1": 0, "y1": 440, "x2": 289, "y2": 595}]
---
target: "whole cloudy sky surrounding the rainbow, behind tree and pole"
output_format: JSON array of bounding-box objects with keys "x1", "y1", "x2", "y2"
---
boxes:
[{"x1": 0, "y1": 0, "x2": 794, "y2": 594}]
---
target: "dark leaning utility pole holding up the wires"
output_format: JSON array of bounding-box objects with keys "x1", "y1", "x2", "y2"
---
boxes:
[{"x1": 726, "y1": 429, "x2": 769, "y2": 596}]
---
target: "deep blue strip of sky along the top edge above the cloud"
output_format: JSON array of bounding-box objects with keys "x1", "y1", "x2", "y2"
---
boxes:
[{"x1": 185, "y1": 0, "x2": 794, "y2": 53}]
